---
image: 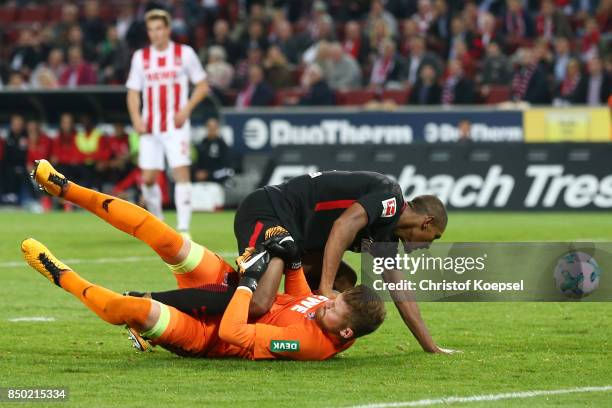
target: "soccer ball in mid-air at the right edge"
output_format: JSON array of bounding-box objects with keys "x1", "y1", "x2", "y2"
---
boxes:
[{"x1": 554, "y1": 251, "x2": 601, "y2": 298}]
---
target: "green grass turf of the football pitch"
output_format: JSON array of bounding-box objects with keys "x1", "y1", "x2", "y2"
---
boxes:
[{"x1": 0, "y1": 212, "x2": 612, "y2": 407}]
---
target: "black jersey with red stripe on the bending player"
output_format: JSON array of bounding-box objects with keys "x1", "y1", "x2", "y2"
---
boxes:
[{"x1": 264, "y1": 171, "x2": 406, "y2": 252}]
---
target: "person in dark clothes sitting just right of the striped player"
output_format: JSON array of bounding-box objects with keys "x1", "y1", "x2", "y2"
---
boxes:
[{"x1": 192, "y1": 118, "x2": 234, "y2": 183}]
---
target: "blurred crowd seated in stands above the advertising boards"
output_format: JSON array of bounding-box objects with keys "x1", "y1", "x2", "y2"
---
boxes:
[{"x1": 0, "y1": 0, "x2": 612, "y2": 107}]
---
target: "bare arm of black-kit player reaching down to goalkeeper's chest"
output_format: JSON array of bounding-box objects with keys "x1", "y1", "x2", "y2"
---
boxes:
[{"x1": 319, "y1": 203, "x2": 368, "y2": 297}]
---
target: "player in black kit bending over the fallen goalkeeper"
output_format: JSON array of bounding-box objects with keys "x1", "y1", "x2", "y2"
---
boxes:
[{"x1": 234, "y1": 171, "x2": 453, "y2": 353}]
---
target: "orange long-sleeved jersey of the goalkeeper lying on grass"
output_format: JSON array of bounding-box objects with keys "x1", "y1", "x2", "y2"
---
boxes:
[{"x1": 206, "y1": 270, "x2": 354, "y2": 360}]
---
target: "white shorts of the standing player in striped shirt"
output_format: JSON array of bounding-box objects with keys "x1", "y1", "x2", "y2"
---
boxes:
[{"x1": 138, "y1": 125, "x2": 191, "y2": 170}]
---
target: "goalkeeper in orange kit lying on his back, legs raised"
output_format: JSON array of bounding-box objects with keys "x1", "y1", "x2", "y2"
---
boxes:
[{"x1": 22, "y1": 160, "x2": 385, "y2": 360}]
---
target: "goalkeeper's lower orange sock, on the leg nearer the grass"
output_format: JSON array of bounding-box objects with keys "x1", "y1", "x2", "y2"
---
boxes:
[{"x1": 60, "y1": 271, "x2": 151, "y2": 328}]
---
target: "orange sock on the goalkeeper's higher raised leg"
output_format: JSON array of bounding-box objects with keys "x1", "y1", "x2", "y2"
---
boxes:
[{"x1": 64, "y1": 182, "x2": 183, "y2": 261}]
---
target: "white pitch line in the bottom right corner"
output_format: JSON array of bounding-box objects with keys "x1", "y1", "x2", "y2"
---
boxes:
[{"x1": 351, "y1": 385, "x2": 612, "y2": 408}]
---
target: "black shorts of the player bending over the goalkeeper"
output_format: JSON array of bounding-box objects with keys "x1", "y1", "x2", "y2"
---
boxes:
[{"x1": 234, "y1": 188, "x2": 283, "y2": 254}]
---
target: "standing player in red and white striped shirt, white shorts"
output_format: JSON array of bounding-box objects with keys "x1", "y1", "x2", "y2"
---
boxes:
[{"x1": 126, "y1": 9, "x2": 209, "y2": 233}]
